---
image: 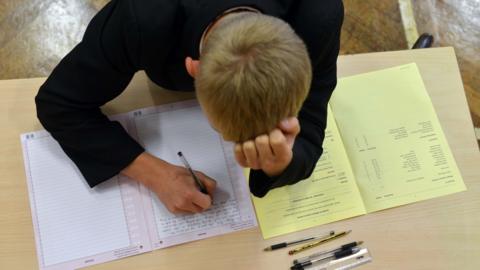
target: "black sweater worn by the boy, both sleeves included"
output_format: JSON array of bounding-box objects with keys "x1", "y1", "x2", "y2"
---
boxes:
[{"x1": 35, "y1": 0, "x2": 343, "y2": 197}]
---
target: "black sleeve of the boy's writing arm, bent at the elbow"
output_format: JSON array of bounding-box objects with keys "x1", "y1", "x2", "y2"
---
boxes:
[{"x1": 35, "y1": 0, "x2": 144, "y2": 187}]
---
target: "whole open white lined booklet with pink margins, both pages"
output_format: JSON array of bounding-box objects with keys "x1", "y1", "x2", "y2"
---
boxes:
[{"x1": 21, "y1": 101, "x2": 256, "y2": 270}]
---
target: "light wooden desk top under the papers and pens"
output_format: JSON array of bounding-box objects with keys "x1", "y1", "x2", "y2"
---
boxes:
[{"x1": 0, "y1": 48, "x2": 480, "y2": 270}]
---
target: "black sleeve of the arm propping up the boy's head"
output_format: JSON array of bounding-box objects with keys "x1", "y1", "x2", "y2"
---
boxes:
[{"x1": 249, "y1": 1, "x2": 343, "y2": 197}]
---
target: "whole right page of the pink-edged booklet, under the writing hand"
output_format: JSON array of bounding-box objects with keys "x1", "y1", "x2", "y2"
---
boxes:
[{"x1": 131, "y1": 100, "x2": 256, "y2": 249}]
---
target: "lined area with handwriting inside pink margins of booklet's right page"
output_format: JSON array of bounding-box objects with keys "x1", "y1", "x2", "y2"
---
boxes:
[{"x1": 135, "y1": 105, "x2": 241, "y2": 238}]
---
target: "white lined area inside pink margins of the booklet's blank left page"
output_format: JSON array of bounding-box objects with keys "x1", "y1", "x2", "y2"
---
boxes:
[{"x1": 23, "y1": 132, "x2": 130, "y2": 266}]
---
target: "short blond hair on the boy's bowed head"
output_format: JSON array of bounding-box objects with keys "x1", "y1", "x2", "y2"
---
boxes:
[{"x1": 195, "y1": 12, "x2": 312, "y2": 142}]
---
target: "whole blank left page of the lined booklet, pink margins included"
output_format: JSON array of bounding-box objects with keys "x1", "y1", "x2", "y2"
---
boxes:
[{"x1": 21, "y1": 130, "x2": 150, "y2": 270}]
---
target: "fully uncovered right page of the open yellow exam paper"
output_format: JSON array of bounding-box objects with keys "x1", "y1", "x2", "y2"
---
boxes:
[{"x1": 330, "y1": 64, "x2": 466, "y2": 212}]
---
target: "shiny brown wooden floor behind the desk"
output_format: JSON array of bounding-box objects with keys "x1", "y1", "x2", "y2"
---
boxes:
[{"x1": 0, "y1": 0, "x2": 480, "y2": 146}]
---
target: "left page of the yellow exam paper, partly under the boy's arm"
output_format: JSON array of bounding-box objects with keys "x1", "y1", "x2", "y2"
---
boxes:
[{"x1": 249, "y1": 106, "x2": 366, "y2": 239}]
